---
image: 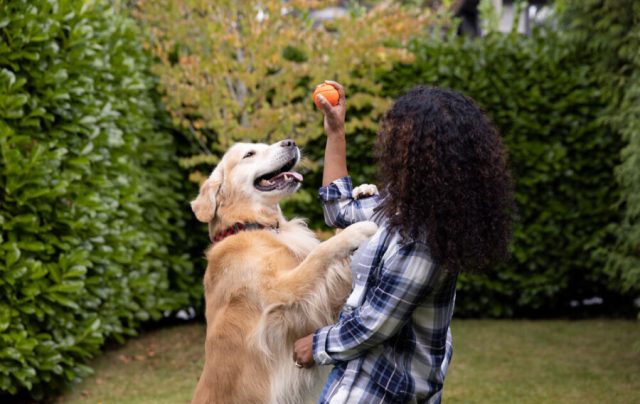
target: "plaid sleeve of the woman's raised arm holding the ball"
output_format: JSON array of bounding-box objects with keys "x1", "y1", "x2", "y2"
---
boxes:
[{"x1": 318, "y1": 176, "x2": 380, "y2": 228}]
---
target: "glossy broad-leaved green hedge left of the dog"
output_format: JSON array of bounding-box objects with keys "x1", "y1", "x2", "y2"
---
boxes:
[{"x1": 0, "y1": 0, "x2": 200, "y2": 397}]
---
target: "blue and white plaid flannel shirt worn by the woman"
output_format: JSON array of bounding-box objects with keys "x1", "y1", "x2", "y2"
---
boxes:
[{"x1": 313, "y1": 177, "x2": 457, "y2": 404}]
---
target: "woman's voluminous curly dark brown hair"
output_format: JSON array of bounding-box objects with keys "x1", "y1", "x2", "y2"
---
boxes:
[{"x1": 376, "y1": 86, "x2": 514, "y2": 271}]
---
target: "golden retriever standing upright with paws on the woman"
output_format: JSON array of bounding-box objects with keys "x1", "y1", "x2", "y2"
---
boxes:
[{"x1": 191, "y1": 140, "x2": 377, "y2": 404}]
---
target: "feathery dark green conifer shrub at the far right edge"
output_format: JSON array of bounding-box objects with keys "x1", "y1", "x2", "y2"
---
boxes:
[{"x1": 558, "y1": 0, "x2": 640, "y2": 294}]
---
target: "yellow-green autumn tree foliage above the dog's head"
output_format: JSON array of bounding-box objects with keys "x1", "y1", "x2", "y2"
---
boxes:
[{"x1": 137, "y1": 0, "x2": 444, "y2": 193}]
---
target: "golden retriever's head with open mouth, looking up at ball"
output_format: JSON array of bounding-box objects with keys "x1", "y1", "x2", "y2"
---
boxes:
[{"x1": 191, "y1": 140, "x2": 302, "y2": 223}]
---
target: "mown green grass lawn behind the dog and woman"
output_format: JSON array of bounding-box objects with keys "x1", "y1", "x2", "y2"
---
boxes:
[{"x1": 57, "y1": 320, "x2": 640, "y2": 404}]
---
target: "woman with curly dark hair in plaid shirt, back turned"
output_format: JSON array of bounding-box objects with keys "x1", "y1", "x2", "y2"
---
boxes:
[{"x1": 294, "y1": 82, "x2": 513, "y2": 404}]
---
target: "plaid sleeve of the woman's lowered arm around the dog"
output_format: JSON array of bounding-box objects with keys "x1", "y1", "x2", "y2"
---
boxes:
[{"x1": 313, "y1": 243, "x2": 438, "y2": 365}]
